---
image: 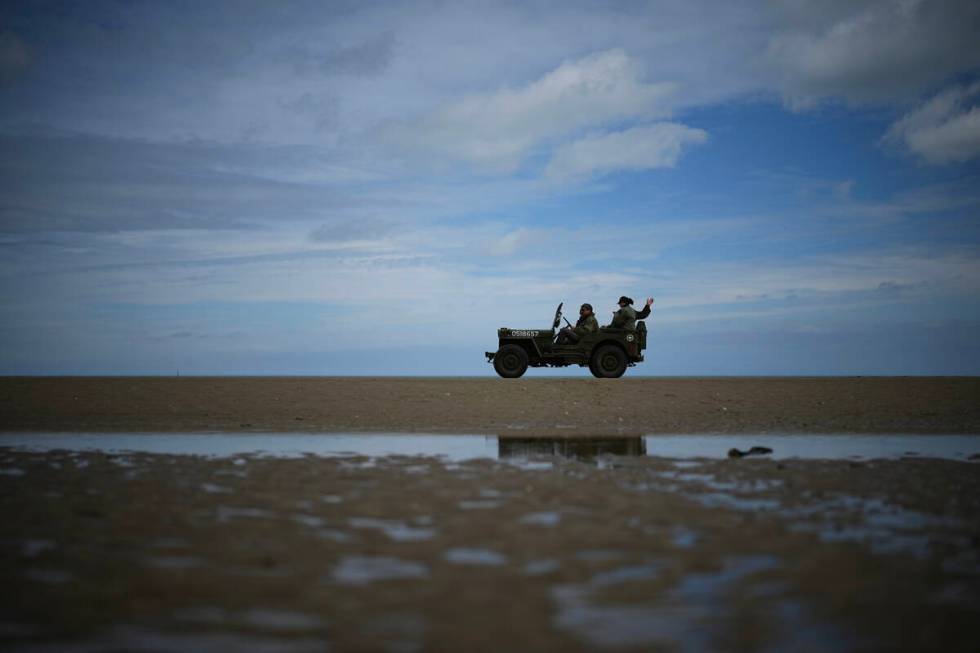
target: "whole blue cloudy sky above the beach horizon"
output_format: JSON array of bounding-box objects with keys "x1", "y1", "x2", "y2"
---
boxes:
[{"x1": 0, "y1": 0, "x2": 980, "y2": 376}]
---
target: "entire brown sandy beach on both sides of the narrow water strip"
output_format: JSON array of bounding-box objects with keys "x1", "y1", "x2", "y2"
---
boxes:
[{"x1": 0, "y1": 378, "x2": 980, "y2": 653}]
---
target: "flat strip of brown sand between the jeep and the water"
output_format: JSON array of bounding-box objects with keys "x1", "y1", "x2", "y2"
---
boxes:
[{"x1": 0, "y1": 370, "x2": 980, "y2": 435}]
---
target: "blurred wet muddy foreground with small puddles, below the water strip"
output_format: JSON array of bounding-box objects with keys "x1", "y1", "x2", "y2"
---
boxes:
[{"x1": 0, "y1": 446, "x2": 980, "y2": 652}]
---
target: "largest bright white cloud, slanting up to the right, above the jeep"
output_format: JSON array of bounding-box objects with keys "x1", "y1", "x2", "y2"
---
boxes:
[{"x1": 389, "y1": 49, "x2": 672, "y2": 171}]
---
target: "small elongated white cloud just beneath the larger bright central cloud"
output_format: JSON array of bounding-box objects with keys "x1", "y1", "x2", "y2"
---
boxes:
[{"x1": 545, "y1": 122, "x2": 708, "y2": 181}]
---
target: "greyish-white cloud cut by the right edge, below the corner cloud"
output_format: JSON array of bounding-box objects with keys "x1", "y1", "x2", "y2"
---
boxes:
[{"x1": 885, "y1": 83, "x2": 980, "y2": 164}]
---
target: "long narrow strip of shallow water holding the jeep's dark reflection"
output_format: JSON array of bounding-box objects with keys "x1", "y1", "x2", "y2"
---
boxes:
[{"x1": 0, "y1": 433, "x2": 980, "y2": 460}]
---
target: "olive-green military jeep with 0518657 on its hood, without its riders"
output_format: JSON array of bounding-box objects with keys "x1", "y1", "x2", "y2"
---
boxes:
[{"x1": 486, "y1": 304, "x2": 647, "y2": 379}]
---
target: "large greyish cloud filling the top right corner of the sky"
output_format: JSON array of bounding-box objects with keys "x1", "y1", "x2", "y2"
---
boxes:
[{"x1": 765, "y1": 0, "x2": 980, "y2": 108}]
